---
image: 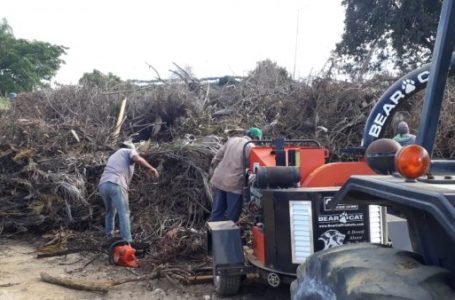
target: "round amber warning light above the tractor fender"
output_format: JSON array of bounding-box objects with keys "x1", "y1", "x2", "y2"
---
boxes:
[{"x1": 395, "y1": 144, "x2": 431, "y2": 179}]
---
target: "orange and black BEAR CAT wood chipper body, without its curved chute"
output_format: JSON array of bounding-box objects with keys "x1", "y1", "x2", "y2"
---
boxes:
[{"x1": 208, "y1": 139, "x2": 387, "y2": 295}]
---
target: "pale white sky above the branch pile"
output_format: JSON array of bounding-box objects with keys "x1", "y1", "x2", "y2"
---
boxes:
[{"x1": 0, "y1": 0, "x2": 344, "y2": 84}]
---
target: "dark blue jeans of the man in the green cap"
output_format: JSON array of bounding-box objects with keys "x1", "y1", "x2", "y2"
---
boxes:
[{"x1": 209, "y1": 188, "x2": 243, "y2": 222}]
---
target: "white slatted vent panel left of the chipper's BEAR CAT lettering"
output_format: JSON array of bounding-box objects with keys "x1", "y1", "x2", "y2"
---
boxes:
[{"x1": 289, "y1": 200, "x2": 314, "y2": 264}]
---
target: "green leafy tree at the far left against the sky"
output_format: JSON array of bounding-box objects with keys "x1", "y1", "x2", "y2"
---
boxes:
[{"x1": 0, "y1": 19, "x2": 67, "y2": 95}]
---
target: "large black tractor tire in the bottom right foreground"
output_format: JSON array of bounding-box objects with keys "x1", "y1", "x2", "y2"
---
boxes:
[{"x1": 291, "y1": 243, "x2": 455, "y2": 300}]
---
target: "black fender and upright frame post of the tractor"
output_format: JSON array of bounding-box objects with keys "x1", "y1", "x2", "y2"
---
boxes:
[{"x1": 331, "y1": 0, "x2": 455, "y2": 274}]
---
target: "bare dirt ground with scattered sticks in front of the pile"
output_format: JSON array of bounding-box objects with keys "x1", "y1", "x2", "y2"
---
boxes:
[{"x1": 0, "y1": 238, "x2": 290, "y2": 300}]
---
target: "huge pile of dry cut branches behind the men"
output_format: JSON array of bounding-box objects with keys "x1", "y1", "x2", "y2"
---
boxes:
[{"x1": 0, "y1": 61, "x2": 455, "y2": 259}]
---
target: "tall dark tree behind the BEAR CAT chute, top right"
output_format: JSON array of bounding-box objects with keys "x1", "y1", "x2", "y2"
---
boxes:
[{"x1": 336, "y1": 0, "x2": 442, "y2": 76}]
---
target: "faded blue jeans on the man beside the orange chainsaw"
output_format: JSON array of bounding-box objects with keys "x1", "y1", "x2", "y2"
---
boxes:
[{"x1": 99, "y1": 182, "x2": 133, "y2": 243}]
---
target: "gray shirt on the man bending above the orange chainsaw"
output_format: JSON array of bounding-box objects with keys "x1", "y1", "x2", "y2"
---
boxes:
[{"x1": 99, "y1": 148, "x2": 138, "y2": 190}]
